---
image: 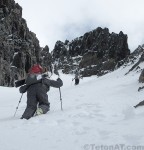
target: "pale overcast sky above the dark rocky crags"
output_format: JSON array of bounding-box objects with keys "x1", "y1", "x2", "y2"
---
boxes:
[{"x1": 15, "y1": 0, "x2": 144, "y2": 51}]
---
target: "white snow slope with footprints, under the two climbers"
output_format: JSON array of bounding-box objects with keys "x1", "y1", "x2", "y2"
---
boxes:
[{"x1": 0, "y1": 66, "x2": 144, "y2": 150}]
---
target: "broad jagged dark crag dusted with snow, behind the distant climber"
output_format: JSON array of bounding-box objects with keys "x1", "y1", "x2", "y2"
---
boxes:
[{"x1": 52, "y1": 27, "x2": 130, "y2": 76}]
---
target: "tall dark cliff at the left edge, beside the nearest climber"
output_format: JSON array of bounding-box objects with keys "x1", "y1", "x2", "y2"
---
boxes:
[{"x1": 0, "y1": 0, "x2": 41, "y2": 86}]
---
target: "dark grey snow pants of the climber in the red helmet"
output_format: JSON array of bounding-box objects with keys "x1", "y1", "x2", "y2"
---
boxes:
[{"x1": 22, "y1": 83, "x2": 50, "y2": 119}]
